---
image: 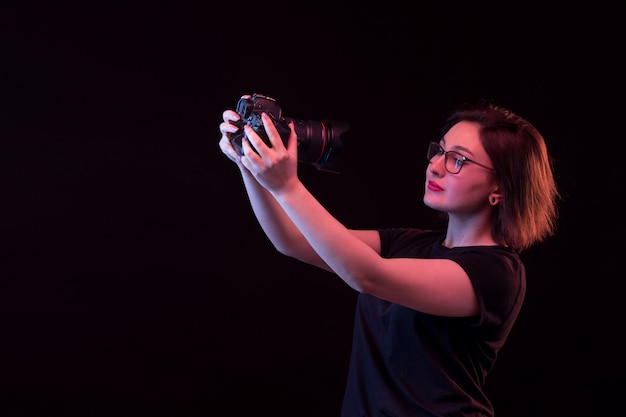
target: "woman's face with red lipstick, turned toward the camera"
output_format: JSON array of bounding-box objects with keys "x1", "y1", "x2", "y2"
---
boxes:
[{"x1": 424, "y1": 121, "x2": 498, "y2": 216}]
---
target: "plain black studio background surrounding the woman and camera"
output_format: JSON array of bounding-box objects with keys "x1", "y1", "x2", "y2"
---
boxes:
[{"x1": 0, "y1": 2, "x2": 626, "y2": 417}]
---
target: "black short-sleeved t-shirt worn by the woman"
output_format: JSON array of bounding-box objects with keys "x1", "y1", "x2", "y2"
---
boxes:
[{"x1": 341, "y1": 229, "x2": 526, "y2": 417}]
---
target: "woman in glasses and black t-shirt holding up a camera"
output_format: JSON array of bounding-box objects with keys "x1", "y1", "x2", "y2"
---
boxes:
[{"x1": 220, "y1": 101, "x2": 559, "y2": 417}]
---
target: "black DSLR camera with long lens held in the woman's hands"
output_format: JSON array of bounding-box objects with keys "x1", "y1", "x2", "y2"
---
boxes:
[{"x1": 230, "y1": 94, "x2": 350, "y2": 173}]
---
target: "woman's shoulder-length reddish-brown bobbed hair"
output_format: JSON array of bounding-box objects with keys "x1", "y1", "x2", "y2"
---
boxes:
[{"x1": 441, "y1": 99, "x2": 560, "y2": 252}]
